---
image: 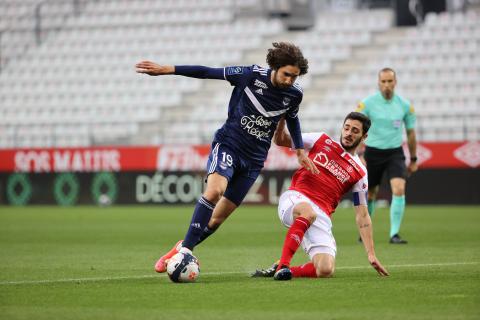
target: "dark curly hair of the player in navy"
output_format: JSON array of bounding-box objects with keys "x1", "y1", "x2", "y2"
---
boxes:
[{"x1": 267, "y1": 42, "x2": 308, "y2": 75}]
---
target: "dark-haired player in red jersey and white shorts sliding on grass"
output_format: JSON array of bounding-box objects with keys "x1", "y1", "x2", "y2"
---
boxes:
[{"x1": 252, "y1": 112, "x2": 388, "y2": 280}]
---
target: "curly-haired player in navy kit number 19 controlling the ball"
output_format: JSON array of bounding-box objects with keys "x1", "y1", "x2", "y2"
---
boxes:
[{"x1": 136, "y1": 42, "x2": 318, "y2": 272}]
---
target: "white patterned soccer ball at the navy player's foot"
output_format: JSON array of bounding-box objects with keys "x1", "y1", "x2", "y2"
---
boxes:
[{"x1": 167, "y1": 252, "x2": 200, "y2": 282}]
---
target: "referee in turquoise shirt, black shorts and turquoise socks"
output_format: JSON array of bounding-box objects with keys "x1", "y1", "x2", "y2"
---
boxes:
[{"x1": 356, "y1": 68, "x2": 417, "y2": 244}]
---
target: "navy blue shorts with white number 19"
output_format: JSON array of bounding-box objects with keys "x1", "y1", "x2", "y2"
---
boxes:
[{"x1": 203, "y1": 141, "x2": 263, "y2": 206}]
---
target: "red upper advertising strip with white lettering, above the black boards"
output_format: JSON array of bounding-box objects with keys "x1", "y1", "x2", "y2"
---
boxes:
[{"x1": 0, "y1": 141, "x2": 480, "y2": 172}]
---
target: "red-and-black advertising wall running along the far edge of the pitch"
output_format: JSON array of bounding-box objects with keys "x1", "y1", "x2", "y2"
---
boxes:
[{"x1": 0, "y1": 142, "x2": 480, "y2": 205}]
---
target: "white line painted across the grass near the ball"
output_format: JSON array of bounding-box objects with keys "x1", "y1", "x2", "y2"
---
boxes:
[{"x1": 0, "y1": 262, "x2": 480, "y2": 286}]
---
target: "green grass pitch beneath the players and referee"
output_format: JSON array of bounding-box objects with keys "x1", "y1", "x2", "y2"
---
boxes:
[{"x1": 0, "y1": 206, "x2": 480, "y2": 320}]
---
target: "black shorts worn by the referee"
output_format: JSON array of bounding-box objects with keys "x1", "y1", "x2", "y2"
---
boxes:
[{"x1": 365, "y1": 146, "x2": 407, "y2": 189}]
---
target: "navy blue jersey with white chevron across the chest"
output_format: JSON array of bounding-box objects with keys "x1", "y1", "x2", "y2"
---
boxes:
[{"x1": 215, "y1": 65, "x2": 303, "y2": 164}]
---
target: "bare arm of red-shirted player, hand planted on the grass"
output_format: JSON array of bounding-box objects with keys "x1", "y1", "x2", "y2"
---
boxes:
[{"x1": 354, "y1": 204, "x2": 389, "y2": 276}]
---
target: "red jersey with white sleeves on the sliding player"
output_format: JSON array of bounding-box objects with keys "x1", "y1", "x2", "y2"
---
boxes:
[{"x1": 290, "y1": 132, "x2": 368, "y2": 216}]
